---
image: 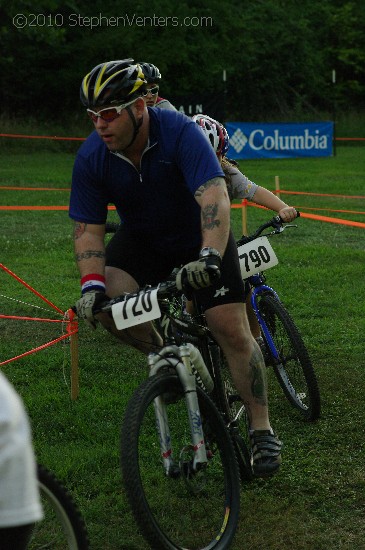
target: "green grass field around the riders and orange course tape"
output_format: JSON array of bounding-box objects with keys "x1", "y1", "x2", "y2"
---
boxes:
[{"x1": 0, "y1": 147, "x2": 365, "y2": 550}]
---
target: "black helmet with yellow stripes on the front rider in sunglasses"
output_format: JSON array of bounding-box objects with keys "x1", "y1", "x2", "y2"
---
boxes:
[{"x1": 80, "y1": 59, "x2": 147, "y2": 108}]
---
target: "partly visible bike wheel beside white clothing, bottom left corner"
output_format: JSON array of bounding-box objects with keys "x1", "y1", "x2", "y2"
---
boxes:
[{"x1": 28, "y1": 465, "x2": 89, "y2": 550}]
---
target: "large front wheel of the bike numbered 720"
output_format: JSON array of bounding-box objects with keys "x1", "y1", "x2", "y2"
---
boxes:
[{"x1": 121, "y1": 373, "x2": 240, "y2": 550}]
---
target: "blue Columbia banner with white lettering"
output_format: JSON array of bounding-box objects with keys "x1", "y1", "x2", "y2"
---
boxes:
[{"x1": 225, "y1": 122, "x2": 333, "y2": 159}]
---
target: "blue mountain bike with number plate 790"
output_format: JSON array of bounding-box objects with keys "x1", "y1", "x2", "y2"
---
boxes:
[{"x1": 237, "y1": 216, "x2": 321, "y2": 421}]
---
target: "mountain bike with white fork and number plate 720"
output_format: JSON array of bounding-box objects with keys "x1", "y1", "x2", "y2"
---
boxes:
[{"x1": 94, "y1": 277, "x2": 243, "y2": 550}]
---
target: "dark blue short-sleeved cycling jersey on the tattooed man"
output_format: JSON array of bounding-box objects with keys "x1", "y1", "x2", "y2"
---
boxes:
[{"x1": 69, "y1": 108, "x2": 224, "y2": 251}]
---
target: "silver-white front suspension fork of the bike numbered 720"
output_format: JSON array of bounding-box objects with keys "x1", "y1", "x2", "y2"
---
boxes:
[{"x1": 148, "y1": 346, "x2": 208, "y2": 476}]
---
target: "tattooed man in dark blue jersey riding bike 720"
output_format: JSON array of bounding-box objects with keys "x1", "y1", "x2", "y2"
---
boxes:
[{"x1": 69, "y1": 59, "x2": 281, "y2": 476}]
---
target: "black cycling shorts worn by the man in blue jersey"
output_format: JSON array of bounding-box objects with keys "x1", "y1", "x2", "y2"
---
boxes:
[{"x1": 106, "y1": 226, "x2": 247, "y2": 311}]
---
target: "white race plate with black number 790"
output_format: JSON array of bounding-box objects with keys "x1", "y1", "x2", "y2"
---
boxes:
[{"x1": 237, "y1": 237, "x2": 279, "y2": 279}]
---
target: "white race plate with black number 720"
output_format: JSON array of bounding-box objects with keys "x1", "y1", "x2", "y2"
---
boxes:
[{"x1": 112, "y1": 289, "x2": 161, "y2": 330}]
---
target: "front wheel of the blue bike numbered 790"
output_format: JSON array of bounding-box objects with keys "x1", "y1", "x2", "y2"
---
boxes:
[{"x1": 258, "y1": 294, "x2": 321, "y2": 421}]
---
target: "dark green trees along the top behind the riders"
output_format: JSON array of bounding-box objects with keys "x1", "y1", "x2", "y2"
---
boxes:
[{"x1": 0, "y1": 0, "x2": 365, "y2": 121}]
